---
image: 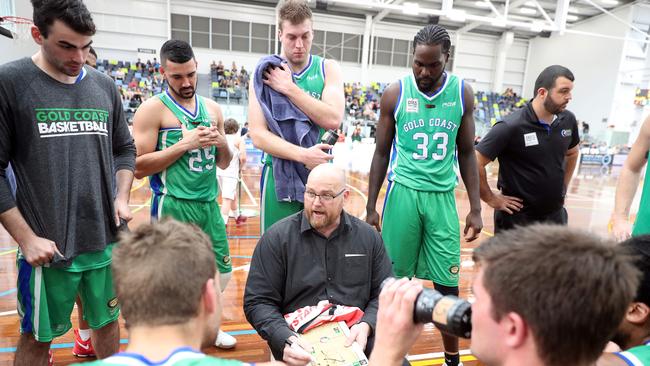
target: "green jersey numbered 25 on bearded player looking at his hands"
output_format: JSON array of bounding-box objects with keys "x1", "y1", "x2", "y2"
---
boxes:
[{"x1": 149, "y1": 91, "x2": 219, "y2": 201}]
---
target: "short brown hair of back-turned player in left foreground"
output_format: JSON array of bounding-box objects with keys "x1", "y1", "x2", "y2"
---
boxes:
[{"x1": 112, "y1": 219, "x2": 216, "y2": 327}]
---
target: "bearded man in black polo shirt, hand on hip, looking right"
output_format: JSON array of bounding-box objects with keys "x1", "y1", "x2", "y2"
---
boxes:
[{"x1": 476, "y1": 65, "x2": 580, "y2": 232}]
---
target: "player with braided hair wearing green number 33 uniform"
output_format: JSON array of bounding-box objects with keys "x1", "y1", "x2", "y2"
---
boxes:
[{"x1": 366, "y1": 25, "x2": 483, "y2": 366}]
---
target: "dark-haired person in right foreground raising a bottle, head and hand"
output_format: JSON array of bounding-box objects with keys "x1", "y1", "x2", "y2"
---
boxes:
[{"x1": 370, "y1": 225, "x2": 639, "y2": 366}]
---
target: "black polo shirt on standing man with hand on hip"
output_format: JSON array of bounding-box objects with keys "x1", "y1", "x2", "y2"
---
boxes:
[{"x1": 476, "y1": 102, "x2": 580, "y2": 215}]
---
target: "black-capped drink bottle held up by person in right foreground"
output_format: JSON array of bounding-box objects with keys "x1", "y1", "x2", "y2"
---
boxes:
[{"x1": 382, "y1": 277, "x2": 472, "y2": 338}]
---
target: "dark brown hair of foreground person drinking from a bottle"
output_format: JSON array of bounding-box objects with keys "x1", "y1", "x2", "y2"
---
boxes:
[{"x1": 473, "y1": 225, "x2": 639, "y2": 366}]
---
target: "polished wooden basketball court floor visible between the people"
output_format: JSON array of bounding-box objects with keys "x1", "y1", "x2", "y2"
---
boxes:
[{"x1": 0, "y1": 164, "x2": 638, "y2": 366}]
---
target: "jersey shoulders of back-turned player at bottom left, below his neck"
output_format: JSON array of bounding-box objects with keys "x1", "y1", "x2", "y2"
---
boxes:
[{"x1": 76, "y1": 347, "x2": 249, "y2": 366}]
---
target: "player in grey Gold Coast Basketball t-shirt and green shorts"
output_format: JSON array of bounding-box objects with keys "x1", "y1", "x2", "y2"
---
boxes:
[{"x1": 0, "y1": 0, "x2": 135, "y2": 366}]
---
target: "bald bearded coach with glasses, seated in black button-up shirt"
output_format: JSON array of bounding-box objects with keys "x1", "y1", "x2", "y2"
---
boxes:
[{"x1": 244, "y1": 164, "x2": 392, "y2": 365}]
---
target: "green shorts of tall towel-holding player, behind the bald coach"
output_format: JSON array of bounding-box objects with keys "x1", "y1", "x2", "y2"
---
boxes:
[{"x1": 260, "y1": 163, "x2": 304, "y2": 234}]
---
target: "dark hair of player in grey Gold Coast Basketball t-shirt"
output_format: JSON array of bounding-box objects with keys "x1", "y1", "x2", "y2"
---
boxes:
[{"x1": 31, "y1": 0, "x2": 95, "y2": 38}]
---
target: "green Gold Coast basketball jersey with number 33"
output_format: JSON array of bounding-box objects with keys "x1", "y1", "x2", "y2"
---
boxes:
[{"x1": 388, "y1": 74, "x2": 464, "y2": 192}]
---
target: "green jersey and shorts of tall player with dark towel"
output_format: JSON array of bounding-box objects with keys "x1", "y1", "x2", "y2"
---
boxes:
[{"x1": 260, "y1": 55, "x2": 325, "y2": 233}]
